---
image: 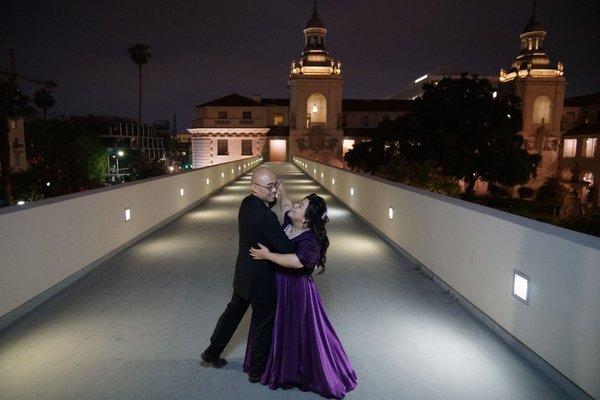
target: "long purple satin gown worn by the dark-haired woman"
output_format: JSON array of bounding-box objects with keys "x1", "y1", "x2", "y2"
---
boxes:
[{"x1": 244, "y1": 215, "x2": 357, "y2": 399}]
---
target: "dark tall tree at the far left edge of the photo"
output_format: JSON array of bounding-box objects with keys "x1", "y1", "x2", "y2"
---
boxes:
[{"x1": 0, "y1": 75, "x2": 33, "y2": 205}]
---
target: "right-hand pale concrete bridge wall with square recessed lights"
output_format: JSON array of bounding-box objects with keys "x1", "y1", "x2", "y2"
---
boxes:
[{"x1": 293, "y1": 157, "x2": 600, "y2": 399}]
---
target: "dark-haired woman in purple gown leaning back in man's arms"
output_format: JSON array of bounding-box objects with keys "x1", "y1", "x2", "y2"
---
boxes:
[{"x1": 244, "y1": 187, "x2": 356, "y2": 399}]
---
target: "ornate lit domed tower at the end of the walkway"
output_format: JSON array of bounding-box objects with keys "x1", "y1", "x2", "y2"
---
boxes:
[{"x1": 288, "y1": 1, "x2": 344, "y2": 166}]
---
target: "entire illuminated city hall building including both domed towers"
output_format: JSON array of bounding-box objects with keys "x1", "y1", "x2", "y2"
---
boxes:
[{"x1": 188, "y1": 3, "x2": 600, "y2": 203}]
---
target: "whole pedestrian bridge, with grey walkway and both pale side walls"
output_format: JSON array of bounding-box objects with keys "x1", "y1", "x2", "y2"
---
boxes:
[{"x1": 0, "y1": 157, "x2": 600, "y2": 400}]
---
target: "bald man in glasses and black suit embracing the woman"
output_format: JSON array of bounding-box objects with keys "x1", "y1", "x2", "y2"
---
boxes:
[{"x1": 201, "y1": 168, "x2": 296, "y2": 383}]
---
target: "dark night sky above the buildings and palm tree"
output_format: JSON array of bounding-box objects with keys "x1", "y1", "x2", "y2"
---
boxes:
[{"x1": 0, "y1": 0, "x2": 600, "y2": 131}]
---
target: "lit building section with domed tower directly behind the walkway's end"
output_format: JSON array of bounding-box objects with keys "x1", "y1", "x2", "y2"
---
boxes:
[{"x1": 188, "y1": 6, "x2": 412, "y2": 168}]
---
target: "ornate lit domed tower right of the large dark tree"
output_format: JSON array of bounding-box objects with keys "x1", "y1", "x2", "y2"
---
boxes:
[{"x1": 499, "y1": 1, "x2": 566, "y2": 188}]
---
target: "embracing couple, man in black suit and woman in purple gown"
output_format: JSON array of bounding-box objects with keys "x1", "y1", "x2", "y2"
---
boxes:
[{"x1": 201, "y1": 168, "x2": 357, "y2": 399}]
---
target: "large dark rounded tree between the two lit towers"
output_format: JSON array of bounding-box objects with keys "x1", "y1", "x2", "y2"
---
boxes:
[{"x1": 403, "y1": 75, "x2": 540, "y2": 195}]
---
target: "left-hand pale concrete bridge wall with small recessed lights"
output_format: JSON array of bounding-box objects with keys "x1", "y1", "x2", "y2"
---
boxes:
[{"x1": 0, "y1": 156, "x2": 262, "y2": 329}]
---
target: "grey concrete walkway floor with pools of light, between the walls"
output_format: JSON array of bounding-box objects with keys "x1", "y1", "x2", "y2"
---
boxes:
[{"x1": 0, "y1": 164, "x2": 568, "y2": 400}]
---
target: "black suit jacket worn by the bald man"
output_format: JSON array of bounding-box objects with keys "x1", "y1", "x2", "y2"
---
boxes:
[{"x1": 233, "y1": 194, "x2": 296, "y2": 303}]
